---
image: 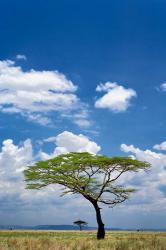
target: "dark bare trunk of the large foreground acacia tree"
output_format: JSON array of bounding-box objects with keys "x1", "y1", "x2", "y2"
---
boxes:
[{"x1": 92, "y1": 202, "x2": 105, "y2": 240}]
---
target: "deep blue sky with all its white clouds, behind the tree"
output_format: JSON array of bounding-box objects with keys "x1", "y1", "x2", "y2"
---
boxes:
[{"x1": 0, "y1": 0, "x2": 166, "y2": 228}]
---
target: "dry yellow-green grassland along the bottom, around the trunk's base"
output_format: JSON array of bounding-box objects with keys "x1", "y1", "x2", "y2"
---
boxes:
[{"x1": 0, "y1": 231, "x2": 166, "y2": 250}]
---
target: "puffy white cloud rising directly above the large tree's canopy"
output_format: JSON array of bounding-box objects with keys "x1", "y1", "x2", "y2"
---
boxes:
[{"x1": 40, "y1": 131, "x2": 101, "y2": 160}]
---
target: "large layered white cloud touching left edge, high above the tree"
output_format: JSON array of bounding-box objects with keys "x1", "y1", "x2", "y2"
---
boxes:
[{"x1": 0, "y1": 60, "x2": 88, "y2": 126}]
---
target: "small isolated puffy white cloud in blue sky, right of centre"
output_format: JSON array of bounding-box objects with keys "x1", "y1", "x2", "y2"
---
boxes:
[{"x1": 95, "y1": 82, "x2": 137, "y2": 112}]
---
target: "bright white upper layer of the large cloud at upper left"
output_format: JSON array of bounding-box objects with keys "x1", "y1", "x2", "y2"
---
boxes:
[{"x1": 0, "y1": 60, "x2": 77, "y2": 93}]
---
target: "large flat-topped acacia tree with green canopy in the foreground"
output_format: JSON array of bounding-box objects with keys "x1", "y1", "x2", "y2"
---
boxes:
[{"x1": 24, "y1": 152, "x2": 150, "y2": 239}]
